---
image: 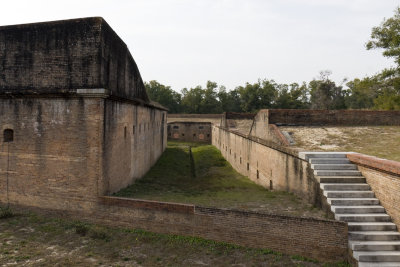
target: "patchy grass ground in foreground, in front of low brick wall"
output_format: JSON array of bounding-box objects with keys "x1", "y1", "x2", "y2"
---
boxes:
[{"x1": 0, "y1": 213, "x2": 349, "y2": 267}]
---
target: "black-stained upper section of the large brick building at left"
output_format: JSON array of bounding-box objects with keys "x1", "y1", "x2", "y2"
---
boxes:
[{"x1": 0, "y1": 17, "x2": 148, "y2": 101}]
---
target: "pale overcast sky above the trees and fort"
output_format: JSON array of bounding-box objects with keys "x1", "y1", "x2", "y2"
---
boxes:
[{"x1": 0, "y1": 0, "x2": 399, "y2": 91}]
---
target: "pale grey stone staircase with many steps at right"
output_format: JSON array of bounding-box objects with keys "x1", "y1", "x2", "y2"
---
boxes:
[{"x1": 300, "y1": 152, "x2": 400, "y2": 267}]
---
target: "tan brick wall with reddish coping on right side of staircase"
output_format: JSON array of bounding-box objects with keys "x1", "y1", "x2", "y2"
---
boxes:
[{"x1": 347, "y1": 153, "x2": 400, "y2": 229}]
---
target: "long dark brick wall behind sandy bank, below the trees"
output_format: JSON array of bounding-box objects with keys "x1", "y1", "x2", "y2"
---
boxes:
[{"x1": 268, "y1": 109, "x2": 400, "y2": 126}]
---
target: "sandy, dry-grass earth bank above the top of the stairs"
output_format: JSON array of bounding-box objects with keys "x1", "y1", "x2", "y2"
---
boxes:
[{"x1": 279, "y1": 126, "x2": 400, "y2": 161}]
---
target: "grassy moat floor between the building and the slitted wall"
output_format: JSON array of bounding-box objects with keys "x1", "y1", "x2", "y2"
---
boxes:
[{"x1": 115, "y1": 142, "x2": 325, "y2": 218}]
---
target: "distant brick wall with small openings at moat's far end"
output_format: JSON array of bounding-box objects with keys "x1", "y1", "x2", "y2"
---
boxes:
[{"x1": 168, "y1": 122, "x2": 211, "y2": 143}]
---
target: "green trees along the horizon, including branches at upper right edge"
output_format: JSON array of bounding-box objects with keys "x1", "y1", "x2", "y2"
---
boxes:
[{"x1": 145, "y1": 7, "x2": 400, "y2": 114}]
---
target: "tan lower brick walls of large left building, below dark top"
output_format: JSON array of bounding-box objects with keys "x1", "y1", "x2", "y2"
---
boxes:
[{"x1": 0, "y1": 97, "x2": 167, "y2": 211}]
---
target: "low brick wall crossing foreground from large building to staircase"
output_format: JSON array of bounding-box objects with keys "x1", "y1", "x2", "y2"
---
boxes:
[{"x1": 10, "y1": 197, "x2": 348, "y2": 261}]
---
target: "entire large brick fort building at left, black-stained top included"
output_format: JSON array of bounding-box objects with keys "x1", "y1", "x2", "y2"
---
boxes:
[{"x1": 0, "y1": 18, "x2": 167, "y2": 214}]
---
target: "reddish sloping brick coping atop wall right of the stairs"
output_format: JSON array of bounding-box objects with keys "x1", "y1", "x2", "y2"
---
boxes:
[{"x1": 347, "y1": 153, "x2": 400, "y2": 176}]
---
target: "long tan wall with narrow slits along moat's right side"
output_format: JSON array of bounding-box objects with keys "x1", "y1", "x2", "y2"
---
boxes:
[{"x1": 212, "y1": 126, "x2": 321, "y2": 205}]
